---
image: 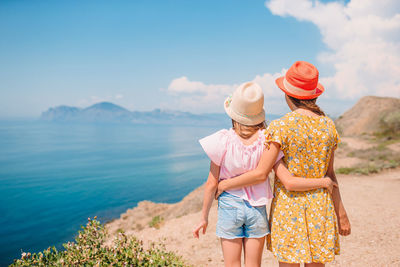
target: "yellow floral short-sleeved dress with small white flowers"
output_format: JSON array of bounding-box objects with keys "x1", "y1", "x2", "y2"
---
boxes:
[{"x1": 266, "y1": 112, "x2": 340, "y2": 263}]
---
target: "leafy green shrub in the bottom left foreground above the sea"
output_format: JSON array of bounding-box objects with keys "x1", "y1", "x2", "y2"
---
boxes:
[{"x1": 10, "y1": 217, "x2": 187, "y2": 266}]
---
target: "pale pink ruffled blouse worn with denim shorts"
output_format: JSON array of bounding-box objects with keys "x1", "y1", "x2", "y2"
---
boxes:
[{"x1": 199, "y1": 129, "x2": 284, "y2": 206}]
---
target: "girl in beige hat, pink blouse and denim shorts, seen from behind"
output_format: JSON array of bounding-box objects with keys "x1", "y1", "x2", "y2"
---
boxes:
[{"x1": 193, "y1": 82, "x2": 335, "y2": 266}]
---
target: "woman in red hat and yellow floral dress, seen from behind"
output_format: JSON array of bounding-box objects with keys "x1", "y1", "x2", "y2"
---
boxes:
[{"x1": 218, "y1": 61, "x2": 351, "y2": 267}]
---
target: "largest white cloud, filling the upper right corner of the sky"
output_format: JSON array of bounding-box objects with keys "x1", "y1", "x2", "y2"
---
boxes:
[{"x1": 266, "y1": 0, "x2": 400, "y2": 98}]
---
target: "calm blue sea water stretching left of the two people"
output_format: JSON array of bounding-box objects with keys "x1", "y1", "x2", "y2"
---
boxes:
[{"x1": 0, "y1": 121, "x2": 229, "y2": 266}]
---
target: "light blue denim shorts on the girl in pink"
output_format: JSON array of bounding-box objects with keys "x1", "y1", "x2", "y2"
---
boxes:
[{"x1": 216, "y1": 192, "x2": 270, "y2": 239}]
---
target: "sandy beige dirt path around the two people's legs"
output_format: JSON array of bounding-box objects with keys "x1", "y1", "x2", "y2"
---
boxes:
[{"x1": 106, "y1": 169, "x2": 400, "y2": 266}]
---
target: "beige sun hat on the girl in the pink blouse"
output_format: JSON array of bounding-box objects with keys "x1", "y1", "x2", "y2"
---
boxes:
[{"x1": 224, "y1": 82, "x2": 265, "y2": 126}]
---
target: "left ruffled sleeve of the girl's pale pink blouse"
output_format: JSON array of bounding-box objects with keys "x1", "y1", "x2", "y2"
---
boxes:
[{"x1": 199, "y1": 129, "x2": 228, "y2": 166}]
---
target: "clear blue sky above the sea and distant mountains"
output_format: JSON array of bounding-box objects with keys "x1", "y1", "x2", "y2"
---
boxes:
[{"x1": 0, "y1": 0, "x2": 398, "y2": 117}]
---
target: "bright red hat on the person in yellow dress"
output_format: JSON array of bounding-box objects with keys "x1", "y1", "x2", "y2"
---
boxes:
[{"x1": 275, "y1": 61, "x2": 325, "y2": 99}]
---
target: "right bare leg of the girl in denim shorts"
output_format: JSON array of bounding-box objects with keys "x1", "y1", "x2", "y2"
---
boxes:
[{"x1": 244, "y1": 237, "x2": 265, "y2": 267}]
